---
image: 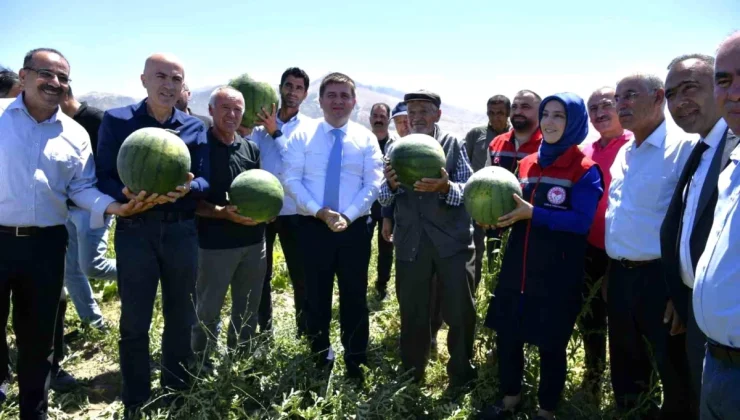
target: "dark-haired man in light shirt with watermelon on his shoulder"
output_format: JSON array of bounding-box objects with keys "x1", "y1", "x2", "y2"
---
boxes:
[{"x1": 251, "y1": 67, "x2": 313, "y2": 336}]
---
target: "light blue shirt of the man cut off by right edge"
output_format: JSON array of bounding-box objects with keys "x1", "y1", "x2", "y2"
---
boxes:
[{"x1": 694, "y1": 146, "x2": 740, "y2": 348}]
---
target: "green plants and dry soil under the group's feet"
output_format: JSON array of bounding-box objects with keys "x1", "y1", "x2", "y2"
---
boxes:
[{"x1": 0, "y1": 231, "x2": 648, "y2": 419}]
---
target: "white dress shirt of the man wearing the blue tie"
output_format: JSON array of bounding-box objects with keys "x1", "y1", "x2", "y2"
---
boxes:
[{"x1": 283, "y1": 120, "x2": 383, "y2": 222}]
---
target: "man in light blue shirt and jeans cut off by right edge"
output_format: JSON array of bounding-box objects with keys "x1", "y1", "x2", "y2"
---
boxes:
[{"x1": 693, "y1": 32, "x2": 740, "y2": 420}]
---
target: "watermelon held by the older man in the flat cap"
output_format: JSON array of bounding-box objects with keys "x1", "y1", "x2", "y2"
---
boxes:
[{"x1": 390, "y1": 134, "x2": 447, "y2": 189}]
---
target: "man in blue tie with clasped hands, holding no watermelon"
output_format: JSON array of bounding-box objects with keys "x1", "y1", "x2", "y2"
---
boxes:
[{"x1": 283, "y1": 73, "x2": 383, "y2": 379}]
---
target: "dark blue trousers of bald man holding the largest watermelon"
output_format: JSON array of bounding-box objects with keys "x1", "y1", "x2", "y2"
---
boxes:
[{"x1": 115, "y1": 212, "x2": 198, "y2": 407}]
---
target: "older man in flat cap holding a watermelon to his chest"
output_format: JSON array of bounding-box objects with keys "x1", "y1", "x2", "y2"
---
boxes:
[{"x1": 379, "y1": 91, "x2": 476, "y2": 389}]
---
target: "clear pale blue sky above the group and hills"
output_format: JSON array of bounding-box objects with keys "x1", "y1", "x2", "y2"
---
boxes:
[{"x1": 0, "y1": 0, "x2": 740, "y2": 111}]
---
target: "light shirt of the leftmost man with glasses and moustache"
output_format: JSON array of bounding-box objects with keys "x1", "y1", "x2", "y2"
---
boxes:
[{"x1": 0, "y1": 94, "x2": 115, "y2": 229}]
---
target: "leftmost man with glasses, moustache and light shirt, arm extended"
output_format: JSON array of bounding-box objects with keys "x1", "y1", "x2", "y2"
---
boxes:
[{"x1": 0, "y1": 48, "x2": 153, "y2": 419}]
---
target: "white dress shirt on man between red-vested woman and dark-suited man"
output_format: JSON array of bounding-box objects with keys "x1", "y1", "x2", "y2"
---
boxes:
[{"x1": 605, "y1": 121, "x2": 696, "y2": 261}]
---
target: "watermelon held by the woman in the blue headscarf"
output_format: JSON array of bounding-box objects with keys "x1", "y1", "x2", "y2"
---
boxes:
[{"x1": 463, "y1": 166, "x2": 522, "y2": 225}]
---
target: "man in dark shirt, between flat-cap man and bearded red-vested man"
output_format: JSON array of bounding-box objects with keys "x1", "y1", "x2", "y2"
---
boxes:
[{"x1": 465, "y1": 95, "x2": 511, "y2": 289}]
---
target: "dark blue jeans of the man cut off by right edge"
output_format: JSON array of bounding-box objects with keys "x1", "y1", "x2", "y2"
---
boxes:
[{"x1": 699, "y1": 350, "x2": 740, "y2": 420}]
